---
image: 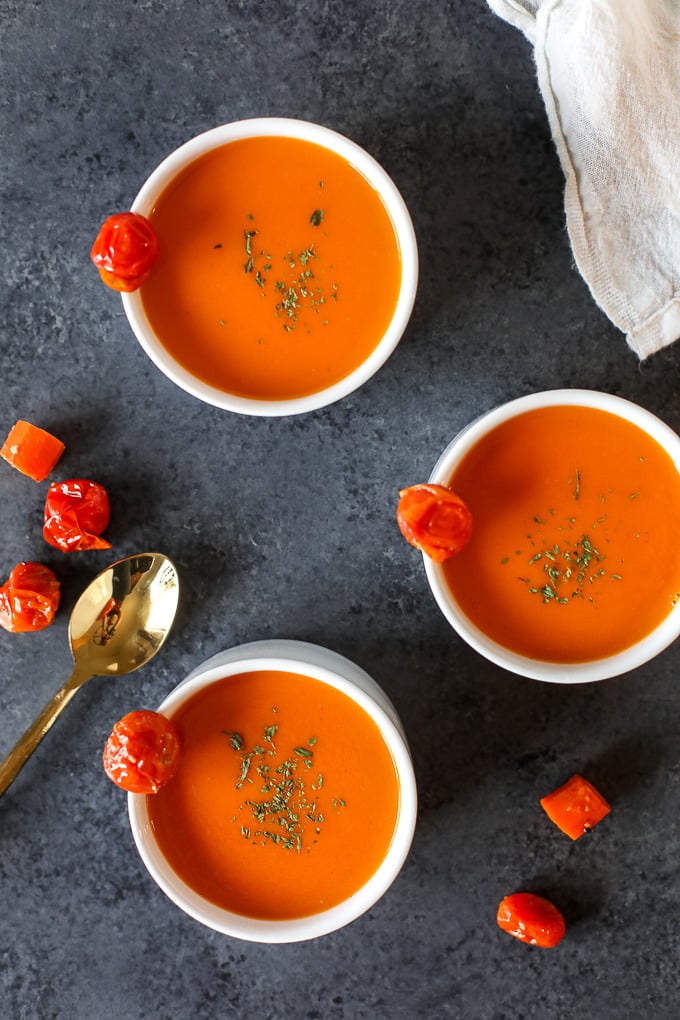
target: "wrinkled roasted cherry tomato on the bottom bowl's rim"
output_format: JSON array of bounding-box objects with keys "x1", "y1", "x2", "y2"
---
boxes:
[{"x1": 103, "y1": 709, "x2": 179, "y2": 794}]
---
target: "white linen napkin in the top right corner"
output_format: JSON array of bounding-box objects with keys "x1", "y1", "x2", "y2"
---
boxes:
[{"x1": 487, "y1": 0, "x2": 680, "y2": 358}]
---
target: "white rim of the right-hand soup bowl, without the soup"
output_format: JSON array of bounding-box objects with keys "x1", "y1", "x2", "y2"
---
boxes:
[{"x1": 423, "y1": 389, "x2": 680, "y2": 683}]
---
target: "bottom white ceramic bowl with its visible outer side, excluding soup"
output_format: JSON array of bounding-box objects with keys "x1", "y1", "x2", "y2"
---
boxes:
[{"x1": 127, "y1": 640, "x2": 417, "y2": 942}]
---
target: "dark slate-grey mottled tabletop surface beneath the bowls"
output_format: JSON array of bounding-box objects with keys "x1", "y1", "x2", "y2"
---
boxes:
[{"x1": 0, "y1": 0, "x2": 680, "y2": 1020}]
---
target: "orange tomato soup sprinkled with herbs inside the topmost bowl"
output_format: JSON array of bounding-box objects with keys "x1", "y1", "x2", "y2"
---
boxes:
[{"x1": 141, "y1": 138, "x2": 402, "y2": 399}]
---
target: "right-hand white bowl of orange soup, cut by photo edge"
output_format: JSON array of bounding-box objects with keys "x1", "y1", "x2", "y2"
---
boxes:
[{"x1": 425, "y1": 390, "x2": 680, "y2": 683}]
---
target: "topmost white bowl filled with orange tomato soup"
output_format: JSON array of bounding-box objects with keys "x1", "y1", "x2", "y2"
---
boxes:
[{"x1": 122, "y1": 117, "x2": 418, "y2": 415}]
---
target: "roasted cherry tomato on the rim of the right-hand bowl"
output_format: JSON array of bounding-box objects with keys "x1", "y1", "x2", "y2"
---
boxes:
[{"x1": 397, "y1": 482, "x2": 472, "y2": 563}]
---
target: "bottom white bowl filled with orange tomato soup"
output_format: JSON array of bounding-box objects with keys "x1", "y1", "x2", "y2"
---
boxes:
[{"x1": 128, "y1": 641, "x2": 417, "y2": 942}]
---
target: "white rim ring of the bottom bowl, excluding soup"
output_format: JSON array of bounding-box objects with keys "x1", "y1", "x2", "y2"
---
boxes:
[{"x1": 127, "y1": 657, "x2": 417, "y2": 944}]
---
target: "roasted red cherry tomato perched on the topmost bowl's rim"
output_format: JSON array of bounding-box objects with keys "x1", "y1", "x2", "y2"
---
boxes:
[{"x1": 90, "y1": 212, "x2": 160, "y2": 292}]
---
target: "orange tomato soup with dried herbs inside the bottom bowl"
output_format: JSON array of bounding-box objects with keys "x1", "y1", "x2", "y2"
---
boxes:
[{"x1": 147, "y1": 671, "x2": 400, "y2": 920}]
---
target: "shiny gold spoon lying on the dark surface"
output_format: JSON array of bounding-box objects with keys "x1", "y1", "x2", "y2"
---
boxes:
[{"x1": 0, "y1": 553, "x2": 179, "y2": 797}]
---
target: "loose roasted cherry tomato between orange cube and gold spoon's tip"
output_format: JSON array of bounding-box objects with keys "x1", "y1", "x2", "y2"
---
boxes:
[{"x1": 43, "y1": 478, "x2": 111, "y2": 553}]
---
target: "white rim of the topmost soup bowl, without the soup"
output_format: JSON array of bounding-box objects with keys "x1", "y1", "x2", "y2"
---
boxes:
[{"x1": 120, "y1": 117, "x2": 418, "y2": 417}]
